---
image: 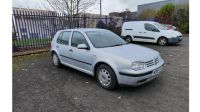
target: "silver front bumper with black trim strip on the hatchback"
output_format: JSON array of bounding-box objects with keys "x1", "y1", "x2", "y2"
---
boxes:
[{"x1": 117, "y1": 61, "x2": 164, "y2": 86}]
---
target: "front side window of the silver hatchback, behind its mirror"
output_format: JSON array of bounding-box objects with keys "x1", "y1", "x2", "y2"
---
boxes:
[{"x1": 71, "y1": 32, "x2": 88, "y2": 47}]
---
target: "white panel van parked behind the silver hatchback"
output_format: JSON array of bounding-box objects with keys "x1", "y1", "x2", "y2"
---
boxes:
[{"x1": 121, "y1": 21, "x2": 182, "y2": 45}]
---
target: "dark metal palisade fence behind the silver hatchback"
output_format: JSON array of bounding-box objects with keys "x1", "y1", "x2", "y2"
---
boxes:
[{"x1": 12, "y1": 10, "x2": 139, "y2": 52}]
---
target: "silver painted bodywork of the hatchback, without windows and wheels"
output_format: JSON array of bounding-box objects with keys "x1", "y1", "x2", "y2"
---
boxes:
[{"x1": 51, "y1": 29, "x2": 164, "y2": 85}]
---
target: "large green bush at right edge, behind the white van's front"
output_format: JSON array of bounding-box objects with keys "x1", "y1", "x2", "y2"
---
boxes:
[{"x1": 156, "y1": 4, "x2": 189, "y2": 33}]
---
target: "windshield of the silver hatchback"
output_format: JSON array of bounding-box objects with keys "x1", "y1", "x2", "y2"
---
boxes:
[{"x1": 85, "y1": 30, "x2": 126, "y2": 48}]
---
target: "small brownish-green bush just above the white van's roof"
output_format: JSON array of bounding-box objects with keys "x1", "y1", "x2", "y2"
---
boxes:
[{"x1": 138, "y1": 9, "x2": 157, "y2": 20}]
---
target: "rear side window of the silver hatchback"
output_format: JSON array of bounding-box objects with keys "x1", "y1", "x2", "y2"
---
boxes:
[{"x1": 57, "y1": 31, "x2": 71, "y2": 45}]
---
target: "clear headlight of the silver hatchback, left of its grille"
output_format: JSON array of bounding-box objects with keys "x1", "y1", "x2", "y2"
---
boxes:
[{"x1": 131, "y1": 61, "x2": 146, "y2": 71}]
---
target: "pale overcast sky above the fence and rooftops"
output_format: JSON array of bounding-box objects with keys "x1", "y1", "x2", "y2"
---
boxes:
[{"x1": 12, "y1": 0, "x2": 163, "y2": 15}]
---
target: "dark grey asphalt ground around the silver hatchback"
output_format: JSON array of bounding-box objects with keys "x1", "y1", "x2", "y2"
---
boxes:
[{"x1": 13, "y1": 37, "x2": 189, "y2": 112}]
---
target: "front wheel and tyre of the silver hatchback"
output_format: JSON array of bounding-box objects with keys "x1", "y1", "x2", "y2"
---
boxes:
[{"x1": 96, "y1": 64, "x2": 117, "y2": 90}]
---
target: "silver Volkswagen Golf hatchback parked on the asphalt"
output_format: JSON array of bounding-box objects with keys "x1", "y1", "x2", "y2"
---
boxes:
[{"x1": 51, "y1": 29, "x2": 164, "y2": 89}]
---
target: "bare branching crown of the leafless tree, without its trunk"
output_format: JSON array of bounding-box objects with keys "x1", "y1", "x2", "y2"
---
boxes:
[{"x1": 46, "y1": 0, "x2": 97, "y2": 17}]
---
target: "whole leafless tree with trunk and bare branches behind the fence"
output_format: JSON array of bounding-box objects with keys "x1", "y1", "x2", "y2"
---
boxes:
[{"x1": 46, "y1": 0, "x2": 97, "y2": 28}]
